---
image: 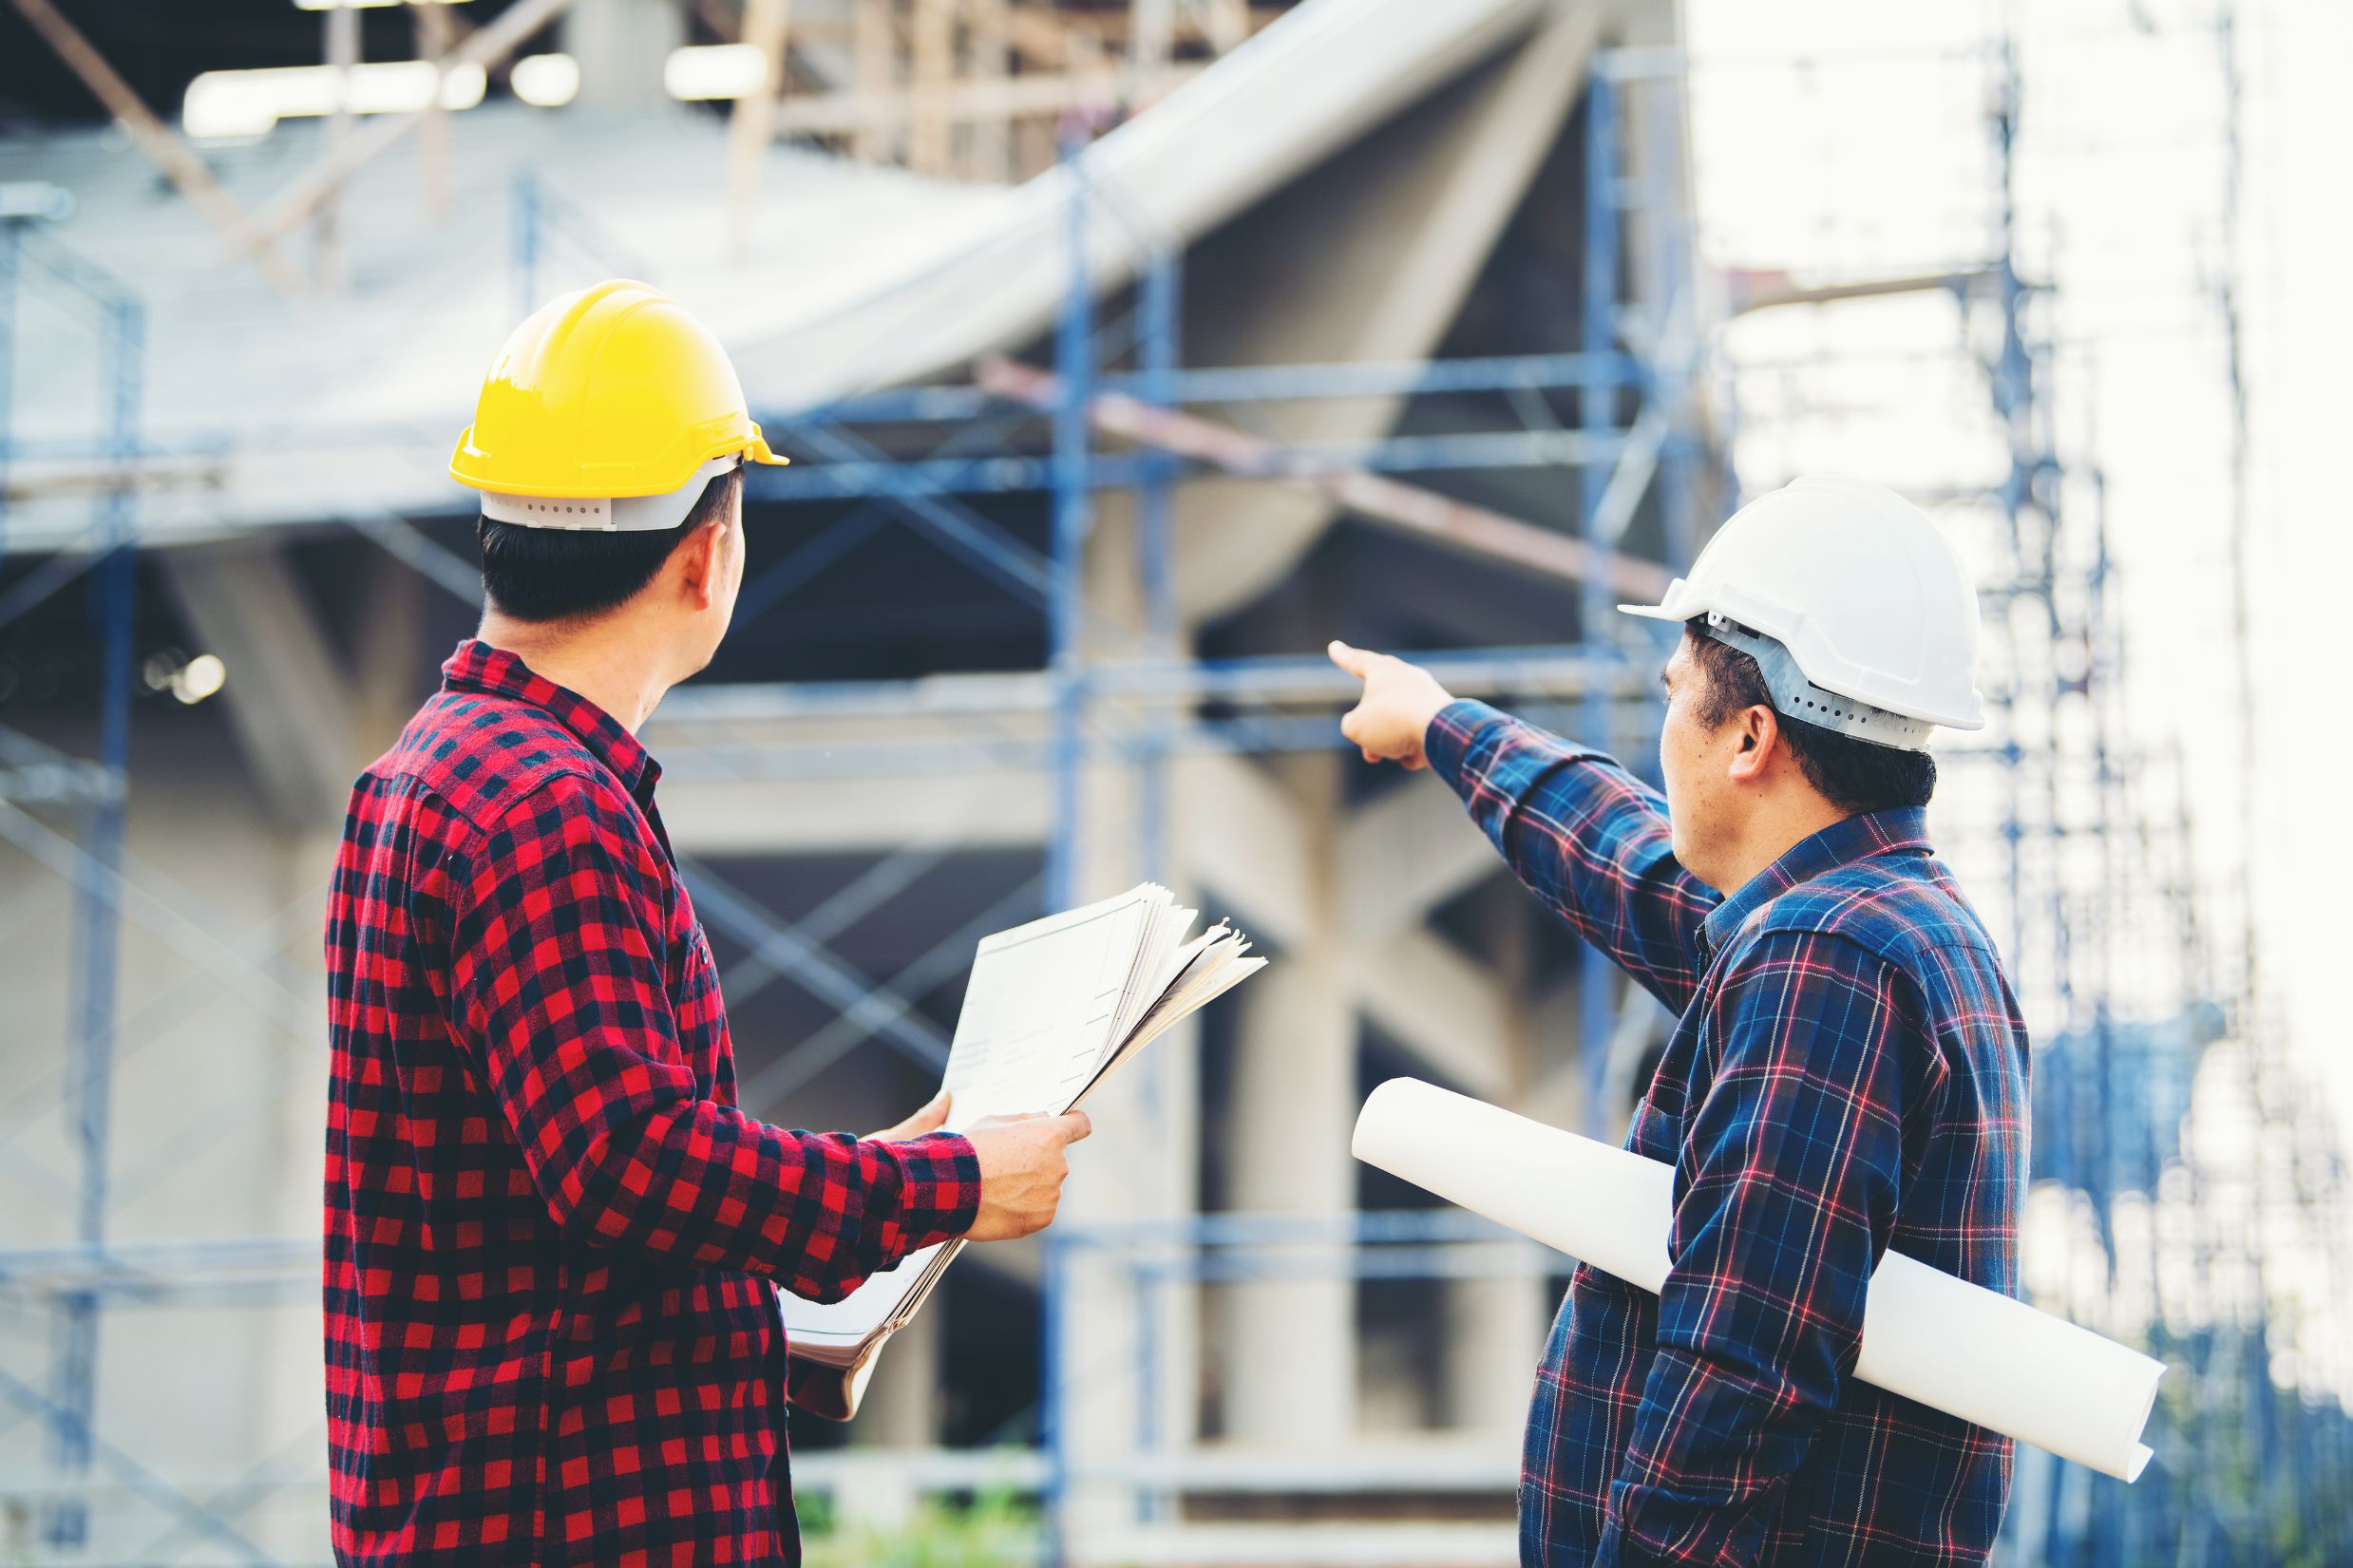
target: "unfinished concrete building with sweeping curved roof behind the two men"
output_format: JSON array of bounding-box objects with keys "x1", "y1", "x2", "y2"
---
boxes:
[{"x1": 0, "y1": 0, "x2": 1716, "y2": 1561}]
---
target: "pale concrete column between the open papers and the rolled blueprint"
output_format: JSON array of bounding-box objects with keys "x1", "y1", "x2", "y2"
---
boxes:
[{"x1": 1224, "y1": 755, "x2": 1357, "y2": 1448}]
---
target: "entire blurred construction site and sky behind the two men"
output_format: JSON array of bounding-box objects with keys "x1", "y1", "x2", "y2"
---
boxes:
[{"x1": 0, "y1": 0, "x2": 2353, "y2": 1568}]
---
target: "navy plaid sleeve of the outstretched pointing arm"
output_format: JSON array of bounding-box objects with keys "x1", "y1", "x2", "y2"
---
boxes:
[{"x1": 1421, "y1": 703, "x2": 1717, "y2": 1013}]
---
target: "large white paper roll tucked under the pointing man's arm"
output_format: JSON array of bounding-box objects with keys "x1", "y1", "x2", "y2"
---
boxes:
[{"x1": 1353, "y1": 1079, "x2": 2165, "y2": 1481}]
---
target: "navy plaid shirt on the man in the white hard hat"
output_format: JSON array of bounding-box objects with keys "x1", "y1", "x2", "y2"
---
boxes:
[{"x1": 1424, "y1": 703, "x2": 2026, "y2": 1568}]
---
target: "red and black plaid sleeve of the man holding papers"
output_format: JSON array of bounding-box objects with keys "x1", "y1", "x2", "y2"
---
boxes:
[{"x1": 452, "y1": 776, "x2": 981, "y2": 1300}]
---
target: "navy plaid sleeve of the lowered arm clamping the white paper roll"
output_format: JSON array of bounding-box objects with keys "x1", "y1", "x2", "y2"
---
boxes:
[{"x1": 1593, "y1": 931, "x2": 1942, "y2": 1568}]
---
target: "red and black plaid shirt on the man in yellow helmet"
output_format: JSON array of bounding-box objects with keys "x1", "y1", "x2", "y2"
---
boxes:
[{"x1": 327, "y1": 642, "x2": 978, "y2": 1566}]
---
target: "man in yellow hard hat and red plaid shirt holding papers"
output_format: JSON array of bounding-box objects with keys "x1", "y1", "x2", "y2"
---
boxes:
[{"x1": 325, "y1": 282, "x2": 1087, "y2": 1566}]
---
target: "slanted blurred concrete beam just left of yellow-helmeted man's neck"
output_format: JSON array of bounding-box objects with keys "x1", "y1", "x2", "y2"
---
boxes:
[{"x1": 155, "y1": 543, "x2": 362, "y2": 827}]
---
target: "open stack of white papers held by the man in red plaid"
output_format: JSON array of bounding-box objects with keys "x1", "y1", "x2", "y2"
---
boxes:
[{"x1": 784, "y1": 881, "x2": 1266, "y2": 1420}]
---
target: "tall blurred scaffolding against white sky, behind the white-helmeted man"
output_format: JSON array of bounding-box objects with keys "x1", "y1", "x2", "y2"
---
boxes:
[{"x1": 1684, "y1": 7, "x2": 2353, "y2": 1566}]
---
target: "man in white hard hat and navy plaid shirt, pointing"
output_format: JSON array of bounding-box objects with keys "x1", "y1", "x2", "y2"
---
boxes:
[{"x1": 1332, "y1": 477, "x2": 2026, "y2": 1568}]
